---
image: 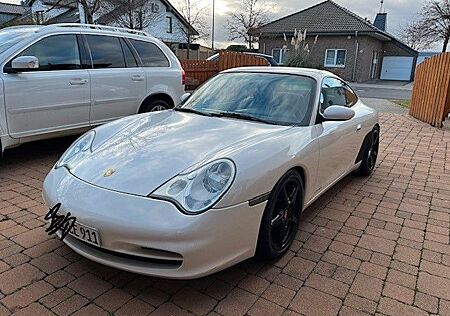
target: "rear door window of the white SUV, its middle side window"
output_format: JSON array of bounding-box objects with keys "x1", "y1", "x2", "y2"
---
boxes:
[{"x1": 86, "y1": 35, "x2": 125, "y2": 69}]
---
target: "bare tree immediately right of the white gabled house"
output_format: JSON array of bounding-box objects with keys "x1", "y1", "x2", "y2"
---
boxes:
[{"x1": 178, "y1": 0, "x2": 209, "y2": 59}]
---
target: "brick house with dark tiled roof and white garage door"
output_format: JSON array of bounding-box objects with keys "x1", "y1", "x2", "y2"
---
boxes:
[{"x1": 252, "y1": 0, "x2": 418, "y2": 82}]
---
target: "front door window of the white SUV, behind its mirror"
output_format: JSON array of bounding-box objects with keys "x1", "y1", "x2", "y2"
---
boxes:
[{"x1": 17, "y1": 35, "x2": 82, "y2": 71}]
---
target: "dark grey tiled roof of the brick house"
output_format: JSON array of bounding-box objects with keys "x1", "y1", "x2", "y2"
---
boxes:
[{"x1": 251, "y1": 0, "x2": 417, "y2": 55}]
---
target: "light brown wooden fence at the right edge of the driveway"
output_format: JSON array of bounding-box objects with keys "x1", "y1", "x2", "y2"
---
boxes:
[{"x1": 409, "y1": 53, "x2": 450, "y2": 127}]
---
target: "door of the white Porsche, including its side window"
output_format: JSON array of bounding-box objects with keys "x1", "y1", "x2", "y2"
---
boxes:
[{"x1": 318, "y1": 77, "x2": 362, "y2": 189}]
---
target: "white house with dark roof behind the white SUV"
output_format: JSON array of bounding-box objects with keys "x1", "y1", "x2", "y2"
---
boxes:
[{"x1": 3, "y1": 0, "x2": 198, "y2": 48}]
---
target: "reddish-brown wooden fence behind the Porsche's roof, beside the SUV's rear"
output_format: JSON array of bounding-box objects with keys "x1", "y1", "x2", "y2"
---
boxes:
[{"x1": 181, "y1": 51, "x2": 268, "y2": 90}]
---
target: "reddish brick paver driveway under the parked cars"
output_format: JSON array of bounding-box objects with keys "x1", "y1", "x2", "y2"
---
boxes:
[{"x1": 0, "y1": 114, "x2": 450, "y2": 315}]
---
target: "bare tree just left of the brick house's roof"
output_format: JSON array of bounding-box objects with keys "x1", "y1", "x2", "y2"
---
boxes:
[{"x1": 226, "y1": 0, "x2": 271, "y2": 49}]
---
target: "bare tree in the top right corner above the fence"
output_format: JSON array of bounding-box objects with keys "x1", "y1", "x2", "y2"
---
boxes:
[{"x1": 404, "y1": 0, "x2": 450, "y2": 52}]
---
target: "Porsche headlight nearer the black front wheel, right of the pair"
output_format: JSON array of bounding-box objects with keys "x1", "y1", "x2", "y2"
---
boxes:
[{"x1": 150, "y1": 159, "x2": 236, "y2": 214}]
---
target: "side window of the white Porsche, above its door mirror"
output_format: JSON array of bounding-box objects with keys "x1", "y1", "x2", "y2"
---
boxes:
[{"x1": 320, "y1": 78, "x2": 358, "y2": 111}]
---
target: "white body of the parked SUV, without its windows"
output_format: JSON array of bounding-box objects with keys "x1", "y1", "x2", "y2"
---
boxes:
[{"x1": 0, "y1": 25, "x2": 184, "y2": 151}]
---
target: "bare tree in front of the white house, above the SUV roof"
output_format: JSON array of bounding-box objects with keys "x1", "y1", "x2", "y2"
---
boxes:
[{"x1": 101, "y1": 0, "x2": 156, "y2": 30}]
